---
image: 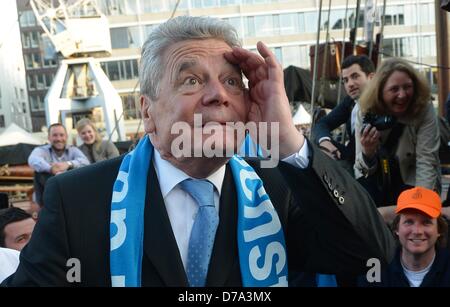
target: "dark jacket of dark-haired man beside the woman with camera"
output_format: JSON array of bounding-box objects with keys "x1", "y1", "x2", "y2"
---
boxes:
[{"x1": 313, "y1": 96, "x2": 355, "y2": 165}]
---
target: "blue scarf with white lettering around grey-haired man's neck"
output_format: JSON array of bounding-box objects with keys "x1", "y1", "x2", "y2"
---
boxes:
[{"x1": 110, "y1": 137, "x2": 288, "y2": 287}]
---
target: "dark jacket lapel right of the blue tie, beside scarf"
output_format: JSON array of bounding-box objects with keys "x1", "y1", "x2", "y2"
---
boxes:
[{"x1": 206, "y1": 164, "x2": 239, "y2": 287}]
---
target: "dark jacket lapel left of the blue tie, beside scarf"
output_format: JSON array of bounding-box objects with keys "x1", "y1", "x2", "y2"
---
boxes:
[{"x1": 144, "y1": 163, "x2": 188, "y2": 286}]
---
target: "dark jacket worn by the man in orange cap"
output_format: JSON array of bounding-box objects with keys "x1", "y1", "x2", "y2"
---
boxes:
[{"x1": 359, "y1": 249, "x2": 450, "y2": 287}]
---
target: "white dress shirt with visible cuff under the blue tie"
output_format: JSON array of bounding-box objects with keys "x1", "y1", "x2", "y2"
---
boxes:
[{"x1": 153, "y1": 140, "x2": 309, "y2": 270}]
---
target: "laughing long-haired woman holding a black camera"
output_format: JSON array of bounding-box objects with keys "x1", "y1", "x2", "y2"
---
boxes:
[{"x1": 354, "y1": 58, "x2": 441, "y2": 222}]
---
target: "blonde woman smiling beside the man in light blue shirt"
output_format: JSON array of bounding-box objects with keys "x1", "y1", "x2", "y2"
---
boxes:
[{"x1": 76, "y1": 118, "x2": 119, "y2": 163}]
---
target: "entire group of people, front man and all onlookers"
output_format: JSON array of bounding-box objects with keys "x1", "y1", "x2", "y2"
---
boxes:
[{"x1": 0, "y1": 16, "x2": 450, "y2": 287}]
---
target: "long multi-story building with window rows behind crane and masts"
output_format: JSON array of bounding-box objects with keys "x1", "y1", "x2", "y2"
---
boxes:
[{"x1": 12, "y1": 0, "x2": 436, "y2": 135}]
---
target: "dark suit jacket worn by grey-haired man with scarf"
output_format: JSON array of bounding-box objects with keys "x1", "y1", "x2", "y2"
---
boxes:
[{"x1": 4, "y1": 143, "x2": 395, "y2": 286}]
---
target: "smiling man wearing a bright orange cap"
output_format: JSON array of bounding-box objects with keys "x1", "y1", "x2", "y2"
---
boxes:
[{"x1": 363, "y1": 187, "x2": 450, "y2": 287}]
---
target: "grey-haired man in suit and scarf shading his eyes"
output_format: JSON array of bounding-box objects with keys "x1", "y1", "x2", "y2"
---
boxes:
[{"x1": 5, "y1": 16, "x2": 395, "y2": 286}]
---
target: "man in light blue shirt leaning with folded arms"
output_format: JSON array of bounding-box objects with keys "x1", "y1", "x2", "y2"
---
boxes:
[{"x1": 28, "y1": 123, "x2": 89, "y2": 207}]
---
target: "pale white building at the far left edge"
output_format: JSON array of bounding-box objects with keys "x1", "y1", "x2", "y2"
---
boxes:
[{"x1": 0, "y1": 0, "x2": 31, "y2": 132}]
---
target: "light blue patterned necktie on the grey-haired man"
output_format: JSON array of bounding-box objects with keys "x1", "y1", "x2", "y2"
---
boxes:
[{"x1": 180, "y1": 179, "x2": 219, "y2": 287}]
